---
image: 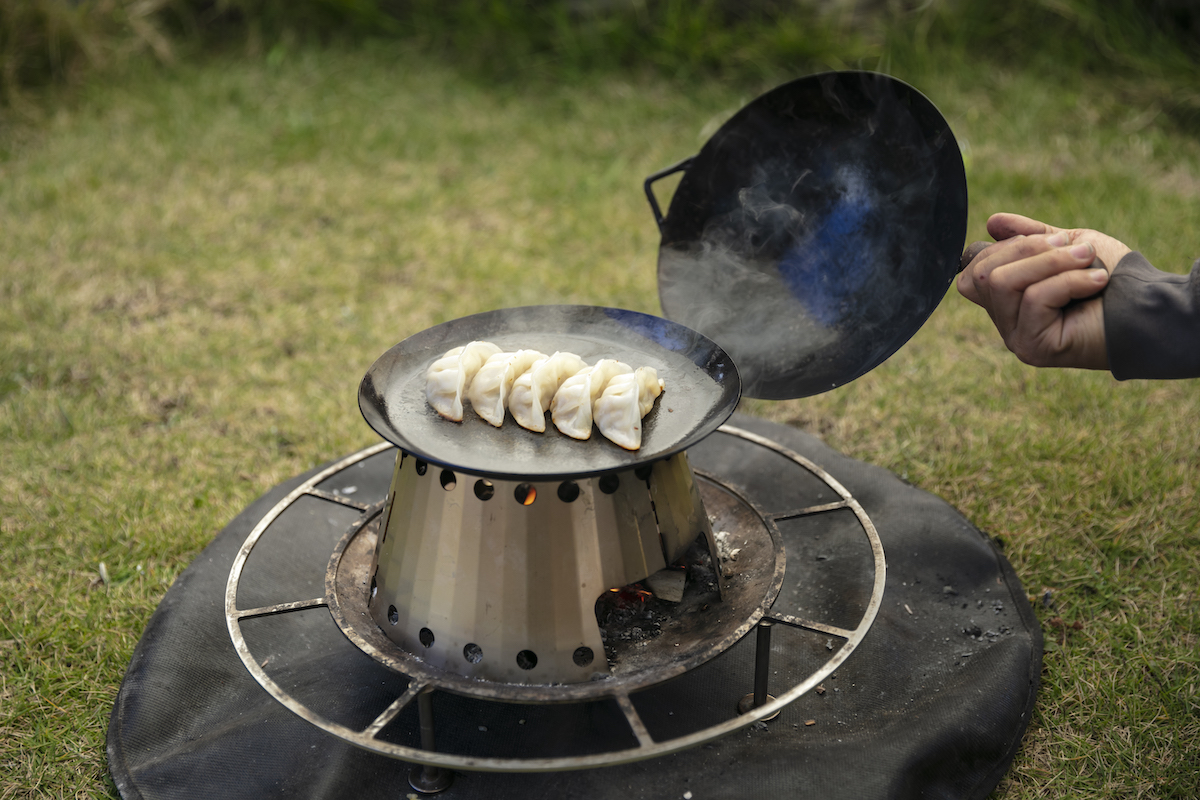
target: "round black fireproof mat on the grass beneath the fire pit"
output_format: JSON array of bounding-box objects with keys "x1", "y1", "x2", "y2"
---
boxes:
[{"x1": 108, "y1": 416, "x2": 1042, "y2": 800}]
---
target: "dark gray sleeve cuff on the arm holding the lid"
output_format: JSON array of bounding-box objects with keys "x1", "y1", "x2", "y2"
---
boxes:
[{"x1": 1104, "y1": 252, "x2": 1200, "y2": 380}]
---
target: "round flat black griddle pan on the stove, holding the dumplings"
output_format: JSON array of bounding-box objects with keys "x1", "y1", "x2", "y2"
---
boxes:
[{"x1": 359, "y1": 306, "x2": 742, "y2": 481}]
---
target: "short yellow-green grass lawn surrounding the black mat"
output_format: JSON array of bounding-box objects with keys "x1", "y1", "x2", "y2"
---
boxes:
[{"x1": 0, "y1": 38, "x2": 1200, "y2": 800}]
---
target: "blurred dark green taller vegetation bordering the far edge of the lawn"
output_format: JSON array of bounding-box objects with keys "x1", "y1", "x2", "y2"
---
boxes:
[{"x1": 7, "y1": 0, "x2": 1200, "y2": 117}]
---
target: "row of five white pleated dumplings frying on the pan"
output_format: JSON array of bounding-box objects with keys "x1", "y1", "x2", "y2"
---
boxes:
[{"x1": 425, "y1": 342, "x2": 664, "y2": 450}]
